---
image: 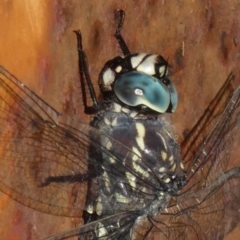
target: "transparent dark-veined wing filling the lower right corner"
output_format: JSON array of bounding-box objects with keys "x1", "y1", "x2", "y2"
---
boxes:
[{"x1": 152, "y1": 87, "x2": 240, "y2": 239}]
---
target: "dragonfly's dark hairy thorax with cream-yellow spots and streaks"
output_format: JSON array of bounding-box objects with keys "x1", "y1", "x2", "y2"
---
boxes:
[{"x1": 86, "y1": 108, "x2": 185, "y2": 219}]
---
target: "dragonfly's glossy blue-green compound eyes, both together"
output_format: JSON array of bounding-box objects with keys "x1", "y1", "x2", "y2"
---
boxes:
[{"x1": 114, "y1": 71, "x2": 177, "y2": 113}]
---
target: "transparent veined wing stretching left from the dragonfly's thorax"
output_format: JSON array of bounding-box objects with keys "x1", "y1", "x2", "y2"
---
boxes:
[{"x1": 0, "y1": 67, "x2": 165, "y2": 217}]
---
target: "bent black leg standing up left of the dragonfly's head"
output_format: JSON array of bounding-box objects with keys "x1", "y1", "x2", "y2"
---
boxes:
[{"x1": 74, "y1": 30, "x2": 99, "y2": 114}]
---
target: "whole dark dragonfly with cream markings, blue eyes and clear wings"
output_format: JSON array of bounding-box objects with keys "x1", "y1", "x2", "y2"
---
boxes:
[{"x1": 0, "y1": 10, "x2": 240, "y2": 240}]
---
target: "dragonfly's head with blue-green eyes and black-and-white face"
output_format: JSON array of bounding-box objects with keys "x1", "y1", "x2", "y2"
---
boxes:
[{"x1": 99, "y1": 53, "x2": 178, "y2": 113}]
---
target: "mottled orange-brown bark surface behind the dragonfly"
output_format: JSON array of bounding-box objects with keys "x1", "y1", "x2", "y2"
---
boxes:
[{"x1": 0, "y1": 0, "x2": 240, "y2": 240}]
